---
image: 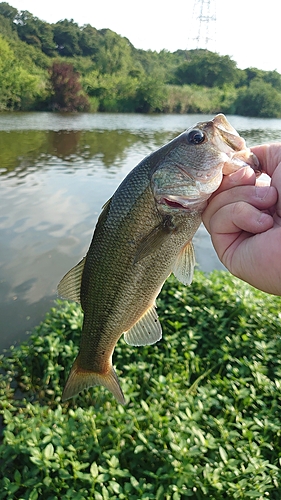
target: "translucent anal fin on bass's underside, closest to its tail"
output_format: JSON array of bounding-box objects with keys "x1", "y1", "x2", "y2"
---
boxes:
[{"x1": 124, "y1": 305, "x2": 162, "y2": 346}]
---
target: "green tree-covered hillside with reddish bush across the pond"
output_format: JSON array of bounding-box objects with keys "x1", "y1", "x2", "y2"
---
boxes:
[{"x1": 0, "y1": 2, "x2": 281, "y2": 117}]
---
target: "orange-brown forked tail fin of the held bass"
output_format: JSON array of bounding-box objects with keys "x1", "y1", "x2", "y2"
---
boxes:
[{"x1": 62, "y1": 359, "x2": 125, "y2": 405}]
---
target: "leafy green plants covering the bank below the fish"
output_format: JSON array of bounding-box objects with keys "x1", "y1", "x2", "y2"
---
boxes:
[{"x1": 0, "y1": 272, "x2": 281, "y2": 500}]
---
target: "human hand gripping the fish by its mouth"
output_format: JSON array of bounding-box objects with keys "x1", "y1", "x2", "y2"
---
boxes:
[{"x1": 203, "y1": 143, "x2": 281, "y2": 295}]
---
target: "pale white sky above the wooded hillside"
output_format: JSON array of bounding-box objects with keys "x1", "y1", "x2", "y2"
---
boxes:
[{"x1": 7, "y1": 0, "x2": 281, "y2": 73}]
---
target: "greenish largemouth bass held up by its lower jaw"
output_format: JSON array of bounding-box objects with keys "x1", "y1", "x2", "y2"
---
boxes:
[{"x1": 58, "y1": 114, "x2": 258, "y2": 404}]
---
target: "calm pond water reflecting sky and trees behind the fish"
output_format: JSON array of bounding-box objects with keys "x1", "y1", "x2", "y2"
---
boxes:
[{"x1": 0, "y1": 113, "x2": 281, "y2": 350}]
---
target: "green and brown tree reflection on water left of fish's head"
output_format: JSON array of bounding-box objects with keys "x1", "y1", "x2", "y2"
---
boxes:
[{"x1": 0, "y1": 130, "x2": 172, "y2": 178}]
